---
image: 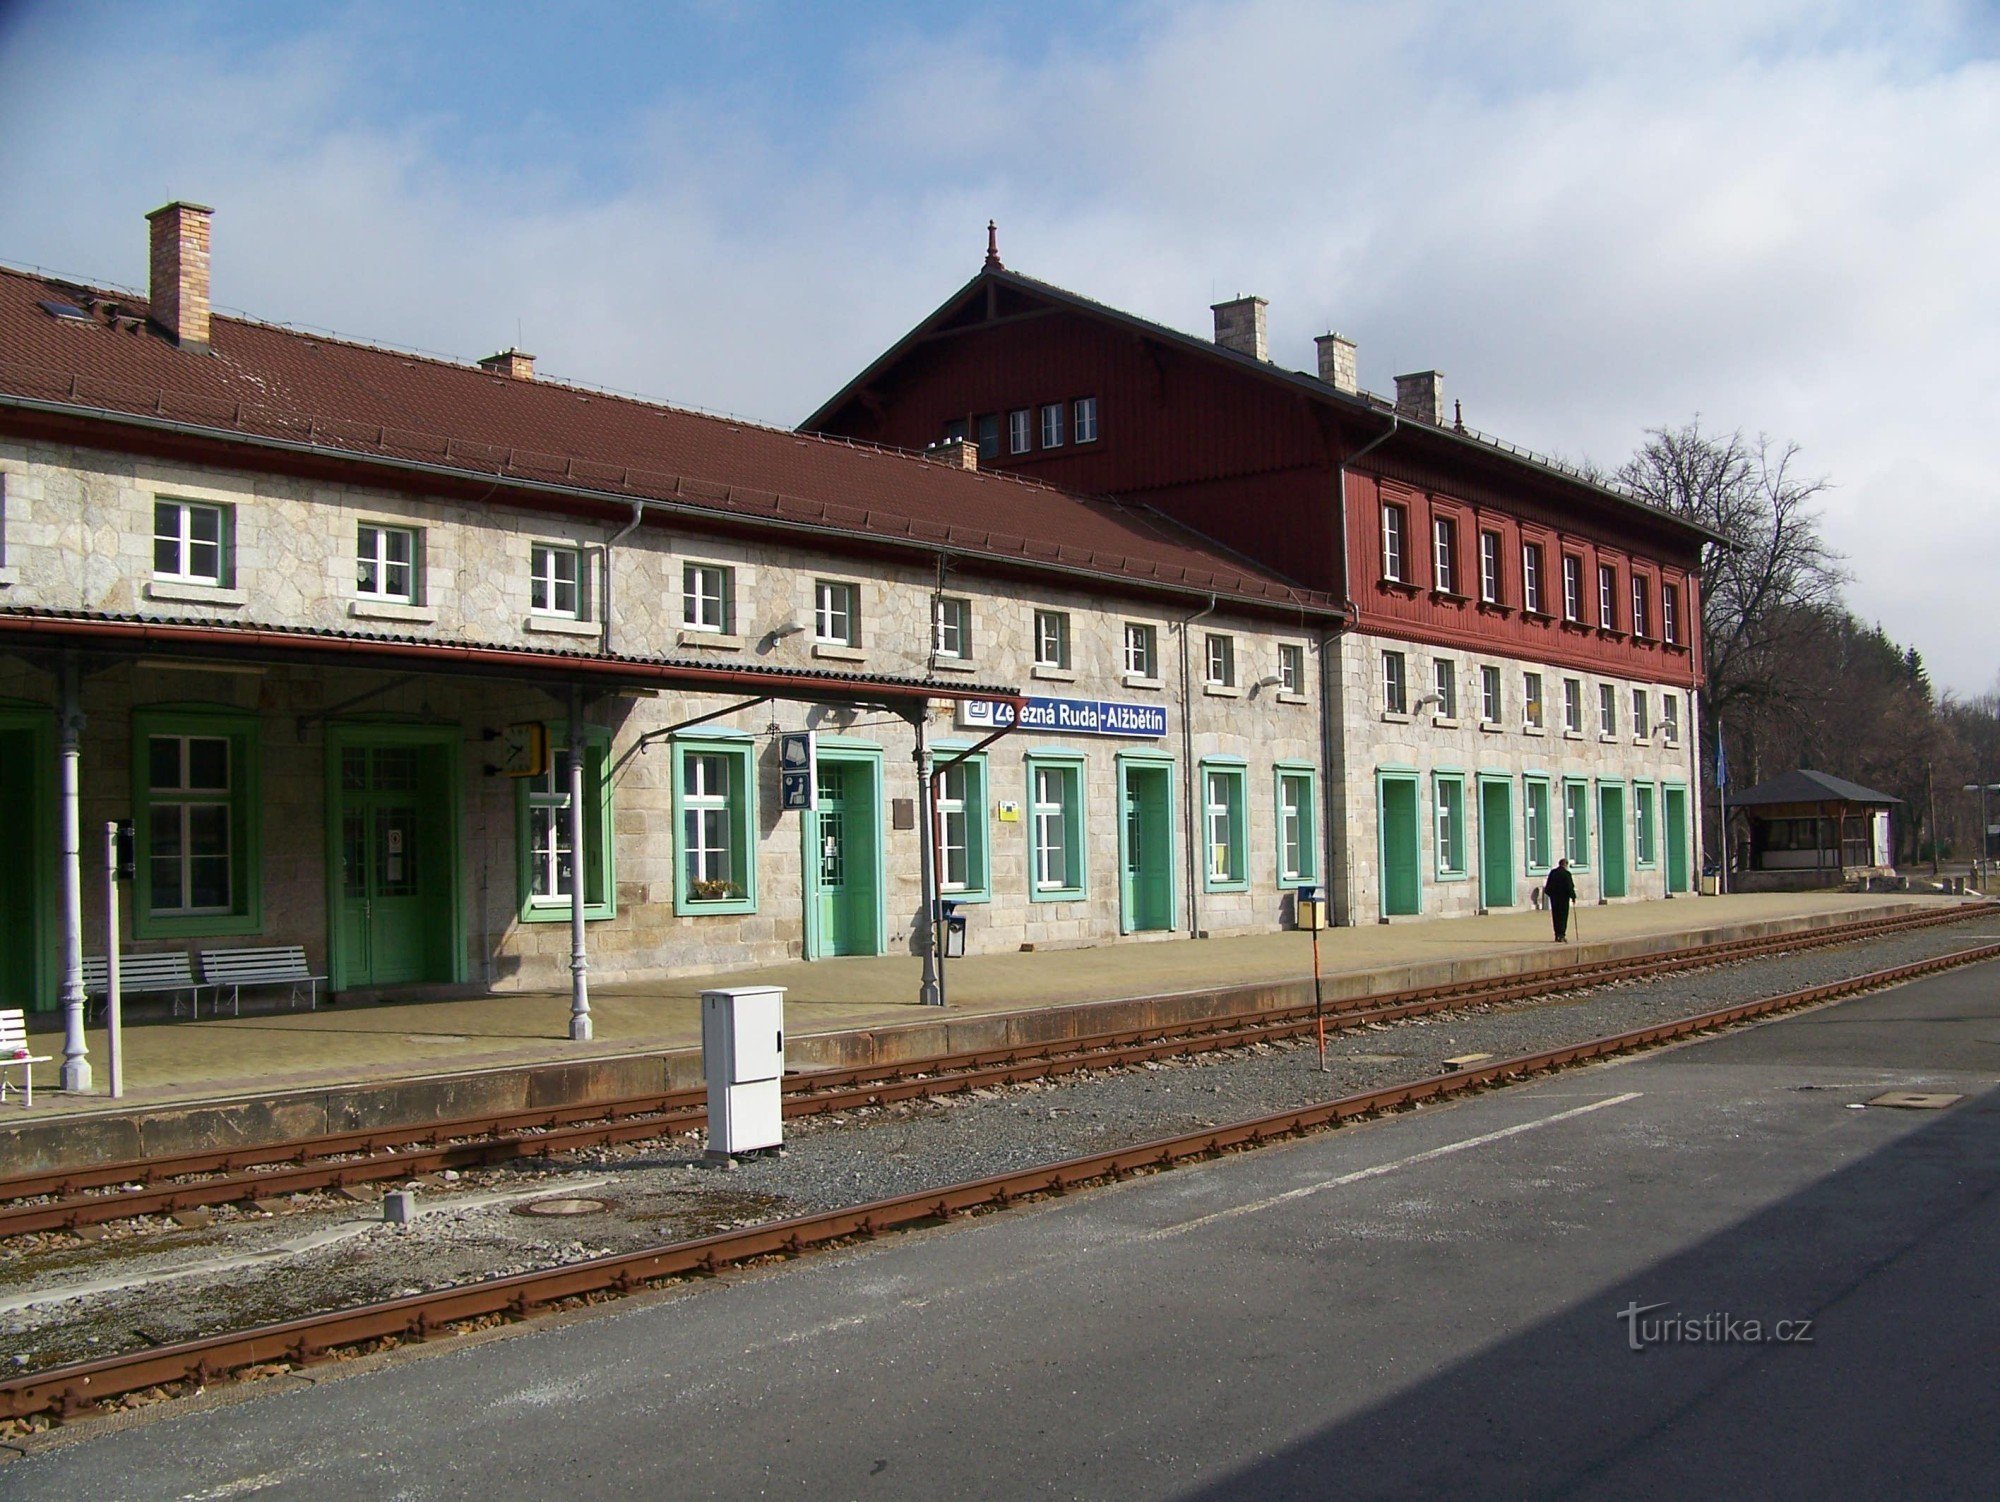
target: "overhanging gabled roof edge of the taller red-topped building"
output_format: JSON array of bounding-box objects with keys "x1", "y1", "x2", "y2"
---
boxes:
[{"x1": 798, "y1": 262, "x2": 1728, "y2": 544}]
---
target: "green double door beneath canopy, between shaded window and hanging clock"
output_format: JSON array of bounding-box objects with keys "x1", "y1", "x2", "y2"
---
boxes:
[{"x1": 334, "y1": 744, "x2": 456, "y2": 988}]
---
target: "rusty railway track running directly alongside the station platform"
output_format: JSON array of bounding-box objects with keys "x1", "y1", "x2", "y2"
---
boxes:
[{"x1": 0, "y1": 906, "x2": 1984, "y2": 1238}]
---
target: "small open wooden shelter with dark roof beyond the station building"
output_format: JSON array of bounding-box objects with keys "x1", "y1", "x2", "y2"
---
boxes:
[{"x1": 1726, "y1": 768, "x2": 1902, "y2": 892}]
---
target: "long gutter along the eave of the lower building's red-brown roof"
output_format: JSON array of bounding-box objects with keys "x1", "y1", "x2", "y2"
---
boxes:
[{"x1": 0, "y1": 394, "x2": 1340, "y2": 620}]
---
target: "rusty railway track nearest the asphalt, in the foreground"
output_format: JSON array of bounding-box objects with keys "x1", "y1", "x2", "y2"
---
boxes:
[{"x1": 11, "y1": 944, "x2": 2000, "y2": 1422}]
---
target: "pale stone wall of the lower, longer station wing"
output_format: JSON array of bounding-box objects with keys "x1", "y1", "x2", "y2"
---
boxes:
[{"x1": 0, "y1": 442, "x2": 1324, "y2": 990}]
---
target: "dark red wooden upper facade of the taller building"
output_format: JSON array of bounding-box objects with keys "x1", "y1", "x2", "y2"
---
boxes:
[{"x1": 802, "y1": 264, "x2": 1708, "y2": 688}]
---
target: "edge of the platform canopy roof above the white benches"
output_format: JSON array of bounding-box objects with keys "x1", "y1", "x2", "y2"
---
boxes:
[{"x1": 0, "y1": 616, "x2": 1022, "y2": 704}]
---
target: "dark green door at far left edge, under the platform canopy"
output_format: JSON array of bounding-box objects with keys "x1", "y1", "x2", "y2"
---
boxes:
[{"x1": 0, "y1": 710, "x2": 54, "y2": 1012}]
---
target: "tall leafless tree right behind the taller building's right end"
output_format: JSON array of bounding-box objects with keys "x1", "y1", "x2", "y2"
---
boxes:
[{"x1": 1616, "y1": 416, "x2": 1846, "y2": 732}]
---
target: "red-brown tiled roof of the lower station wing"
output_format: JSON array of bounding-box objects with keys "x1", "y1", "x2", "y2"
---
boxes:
[{"x1": 0, "y1": 268, "x2": 1336, "y2": 614}]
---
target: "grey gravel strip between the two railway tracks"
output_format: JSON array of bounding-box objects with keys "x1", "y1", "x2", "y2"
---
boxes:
[{"x1": 0, "y1": 928, "x2": 1990, "y2": 1372}]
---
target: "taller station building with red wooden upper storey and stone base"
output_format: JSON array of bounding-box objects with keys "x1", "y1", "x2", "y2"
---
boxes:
[{"x1": 802, "y1": 226, "x2": 1716, "y2": 922}]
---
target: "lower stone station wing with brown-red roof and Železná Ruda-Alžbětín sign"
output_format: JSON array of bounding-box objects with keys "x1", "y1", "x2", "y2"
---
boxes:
[{"x1": 0, "y1": 204, "x2": 1342, "y2": 1088}]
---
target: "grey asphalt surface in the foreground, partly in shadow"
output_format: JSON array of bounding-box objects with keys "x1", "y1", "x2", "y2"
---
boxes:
[{"x1": 0, "y1": 966, "x2": 2000, "y2": 1502}]
